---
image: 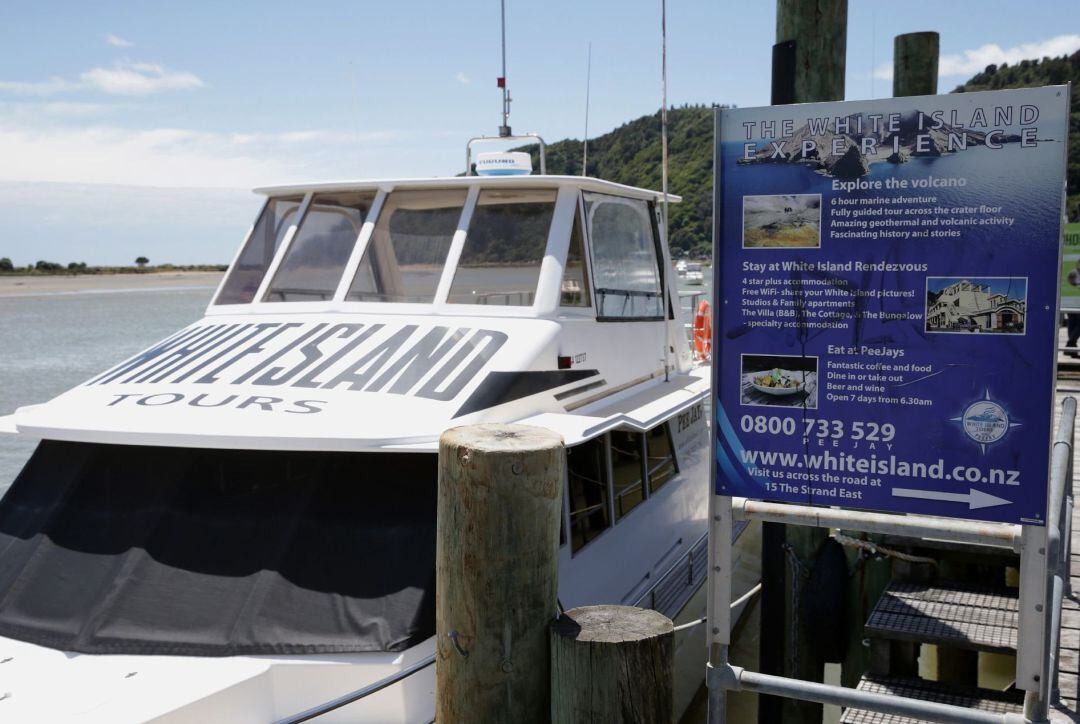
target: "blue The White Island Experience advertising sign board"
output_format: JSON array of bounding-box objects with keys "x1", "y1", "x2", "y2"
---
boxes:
[{"x1": 714, "y1": 86, "x2": 1068, "y2": 524}]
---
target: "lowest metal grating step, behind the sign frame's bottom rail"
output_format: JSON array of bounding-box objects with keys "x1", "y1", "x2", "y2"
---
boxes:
[{"x1": 840, "y1": 675, "x2": 1024, "y2": 724}]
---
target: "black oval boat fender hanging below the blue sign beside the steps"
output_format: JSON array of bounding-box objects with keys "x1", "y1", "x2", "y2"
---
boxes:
[{"x1": 802, "y1": 538, "x2": 848, "y2": 663}]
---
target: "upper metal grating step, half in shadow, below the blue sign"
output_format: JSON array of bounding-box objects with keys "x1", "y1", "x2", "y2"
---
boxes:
[{"x1": 866, "y1": 581, "x2": 1018, "y2": 654}]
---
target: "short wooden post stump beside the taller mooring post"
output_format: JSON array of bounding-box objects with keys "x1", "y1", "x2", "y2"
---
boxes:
[{"x1": 551, "y1": 606, "x2": 675, "y2": 724}]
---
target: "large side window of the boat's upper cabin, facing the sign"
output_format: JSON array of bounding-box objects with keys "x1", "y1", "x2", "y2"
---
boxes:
[{"x1": 584, "y1": 192, "x2": 663, "y2": 320}]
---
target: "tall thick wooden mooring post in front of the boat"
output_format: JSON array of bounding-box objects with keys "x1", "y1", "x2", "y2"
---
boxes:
[{"x1": 435, "y1": 425, "x2": 565, "y2": 724}]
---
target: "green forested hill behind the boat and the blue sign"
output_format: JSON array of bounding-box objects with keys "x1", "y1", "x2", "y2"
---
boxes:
[{"x1": 518, "y1": 52, "x2": 1080, "y2": 255}]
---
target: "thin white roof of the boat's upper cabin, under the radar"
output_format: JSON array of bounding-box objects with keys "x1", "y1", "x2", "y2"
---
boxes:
[{"x1": 255, "y1": 175, "x2": 683, "y2": 203}]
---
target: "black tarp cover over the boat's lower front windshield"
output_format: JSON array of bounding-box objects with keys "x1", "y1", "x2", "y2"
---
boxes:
[{"x1": 0, "y1": 441, "x2": 436, "y2": 656}]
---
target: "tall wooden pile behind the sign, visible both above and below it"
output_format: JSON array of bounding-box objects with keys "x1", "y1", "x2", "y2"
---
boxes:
[{"x1": 758, "y1": 0, "x2": 848, "y2": 724}]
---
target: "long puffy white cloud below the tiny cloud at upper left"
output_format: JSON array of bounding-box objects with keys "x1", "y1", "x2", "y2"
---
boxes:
[{"x1": 0, "y1": 61, "x2": 205, "y2": 96}]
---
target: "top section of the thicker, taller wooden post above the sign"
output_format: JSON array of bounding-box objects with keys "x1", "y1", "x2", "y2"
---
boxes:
[{"x1": 777, "y1": 0, "x2": 848, "y2": 103}]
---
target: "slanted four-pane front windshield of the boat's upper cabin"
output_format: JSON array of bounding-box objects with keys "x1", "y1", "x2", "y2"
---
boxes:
[{"x1": 215, "y1": 188, "x2": 561, "y2": 307}]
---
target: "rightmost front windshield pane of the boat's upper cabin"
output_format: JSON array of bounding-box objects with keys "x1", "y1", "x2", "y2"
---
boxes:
[{"x1": 446, "y1": 189, "x2": 555, "y2": 307}]
